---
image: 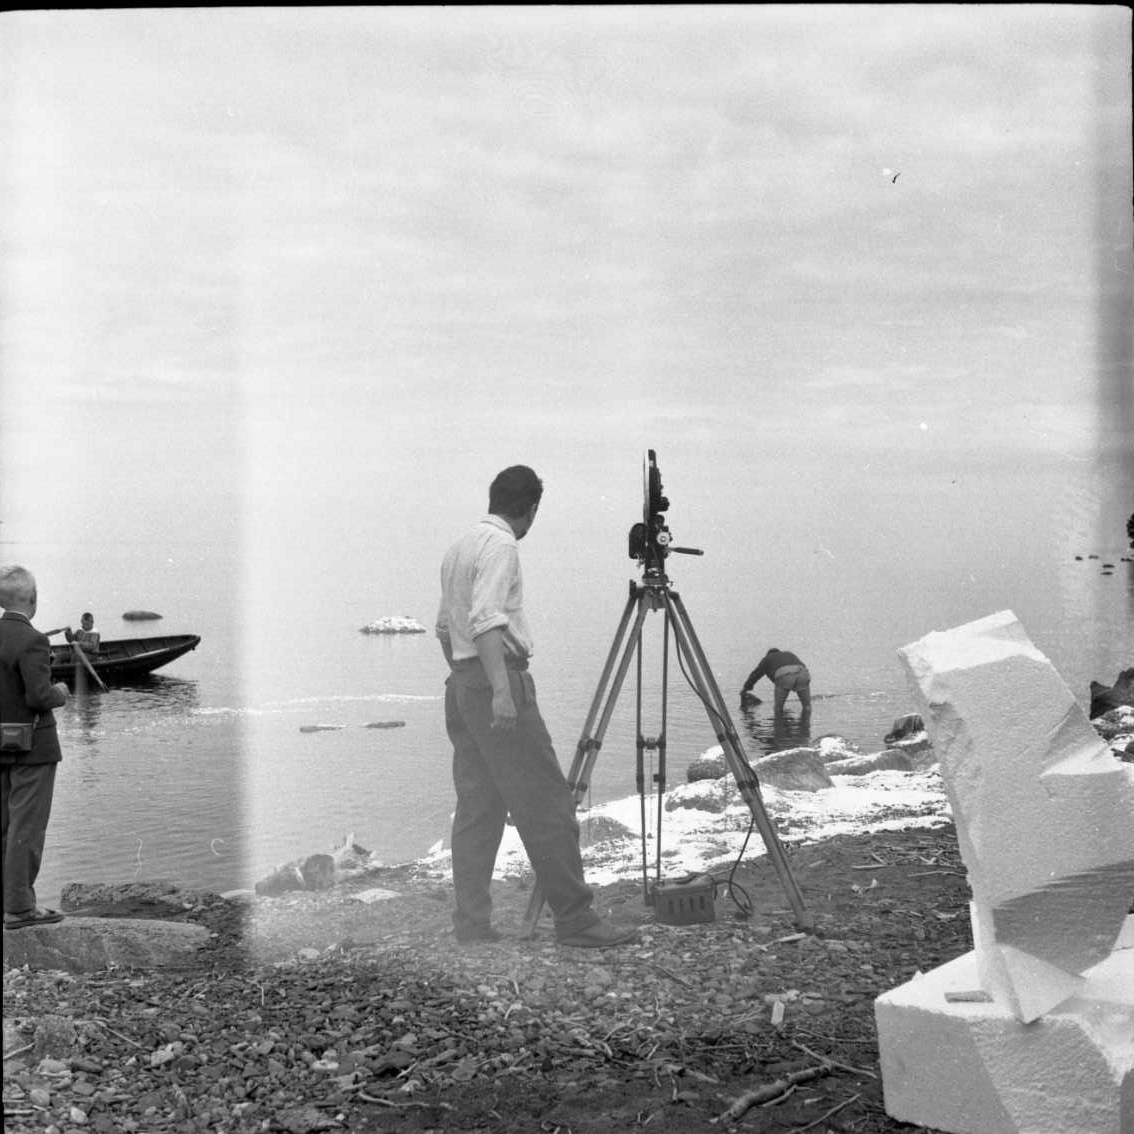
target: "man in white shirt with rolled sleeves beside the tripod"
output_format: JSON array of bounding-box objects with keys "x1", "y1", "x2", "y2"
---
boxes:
[{"x1": 437, "y1": 465, "x2": 636, "y2": 948}]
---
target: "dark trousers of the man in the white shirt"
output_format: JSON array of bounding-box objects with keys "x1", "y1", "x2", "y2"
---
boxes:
[{"x1": 445, "y1": 659, "x2": 599, "y2": 936}]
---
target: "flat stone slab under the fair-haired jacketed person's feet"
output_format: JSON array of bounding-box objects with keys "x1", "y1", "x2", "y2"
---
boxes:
[{"x1": 3, "y1": 917, "x2": 210, "y2": 973}]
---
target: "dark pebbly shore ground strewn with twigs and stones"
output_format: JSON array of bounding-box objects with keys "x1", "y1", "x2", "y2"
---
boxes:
[{"x1": 3, "y1": 824, "x2": 972, "y2": 1134}]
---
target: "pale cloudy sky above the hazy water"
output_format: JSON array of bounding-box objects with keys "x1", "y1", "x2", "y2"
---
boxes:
[{"x1": 0, "y1": 5, "x2": 1134, "y2": 553}]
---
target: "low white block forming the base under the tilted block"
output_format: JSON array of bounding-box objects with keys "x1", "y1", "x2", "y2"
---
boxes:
[{"x1": 874, "y1": 919, "x2": 1134, "y2": 1134}]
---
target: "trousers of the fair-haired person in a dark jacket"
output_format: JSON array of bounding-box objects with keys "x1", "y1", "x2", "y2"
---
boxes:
[{"x1": 0, "y1": 763, "x2": 58, "y2": 914}]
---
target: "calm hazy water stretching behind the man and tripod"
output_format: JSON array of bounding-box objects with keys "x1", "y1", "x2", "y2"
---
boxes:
[{"x1": 3, "y1": 450, "x2": 1134, "y2": 898}]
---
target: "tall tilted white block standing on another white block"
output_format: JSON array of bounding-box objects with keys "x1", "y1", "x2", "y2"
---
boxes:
[{"x1": 899, "y1": 611, "x2": 1134, "y2": 1021}]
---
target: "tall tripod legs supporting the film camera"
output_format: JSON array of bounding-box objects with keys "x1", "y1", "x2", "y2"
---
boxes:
[{"x1": 523, "y1": 571, "x2": 813, "y2": 937}]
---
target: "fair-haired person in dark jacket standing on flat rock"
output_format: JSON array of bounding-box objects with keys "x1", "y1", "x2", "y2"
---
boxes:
[{"x1": 0, "y1": 567, "x2": 67, "y2": 931}]
